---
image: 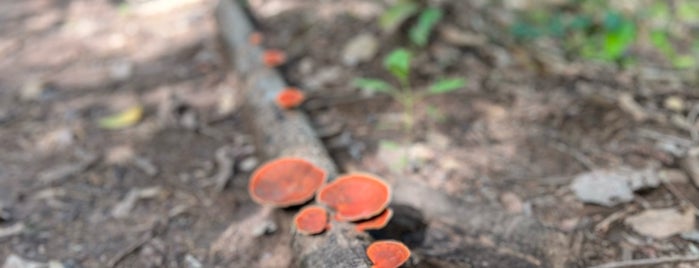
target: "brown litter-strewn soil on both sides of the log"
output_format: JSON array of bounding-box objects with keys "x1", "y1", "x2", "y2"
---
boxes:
[{"x1": 0, "y1": 0, "x2": 699, "y2": 267}]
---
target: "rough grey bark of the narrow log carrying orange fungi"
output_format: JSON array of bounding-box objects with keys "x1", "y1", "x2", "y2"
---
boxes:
[{"x1": 217, "y1": 0, "x2": 370, "y2": 268}]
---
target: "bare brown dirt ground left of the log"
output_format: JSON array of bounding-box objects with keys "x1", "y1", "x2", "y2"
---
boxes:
[{"x1": 0, "y1": 0, "x2": 284, "y2": 267}]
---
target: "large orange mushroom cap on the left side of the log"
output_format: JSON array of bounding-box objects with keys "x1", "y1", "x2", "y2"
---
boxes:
[{"x1": 248, "y1": 157, "x2": 326, "y2": 207}]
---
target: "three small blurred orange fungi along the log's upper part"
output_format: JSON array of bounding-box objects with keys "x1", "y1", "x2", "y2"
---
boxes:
[{"x1": 249, "y1": 32, "x2": 306, "y2": 110}]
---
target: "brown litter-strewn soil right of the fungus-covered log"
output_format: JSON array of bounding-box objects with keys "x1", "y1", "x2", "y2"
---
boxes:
[{"x1": 250, "y1": 0, "x2": 699, "y2": 267}]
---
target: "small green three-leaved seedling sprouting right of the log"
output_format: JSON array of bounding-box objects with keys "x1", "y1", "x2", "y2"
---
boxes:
[{"x1": 354, "y1": 48, "x2": 466, "y2": 132}]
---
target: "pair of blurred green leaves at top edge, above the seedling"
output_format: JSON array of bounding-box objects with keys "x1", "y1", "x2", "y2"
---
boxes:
[{"x1": 379, "y1": 0, "x2": 443, "y2": 47}]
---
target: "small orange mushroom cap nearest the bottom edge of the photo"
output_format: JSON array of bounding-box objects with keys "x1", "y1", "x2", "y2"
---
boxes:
[{"x1": 366, "y1": 240, "x2": 410, "y2": 268}]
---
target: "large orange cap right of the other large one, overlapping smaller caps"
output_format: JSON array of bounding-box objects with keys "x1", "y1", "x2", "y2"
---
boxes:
[{"x1": 317, "y1": 174, "x2": 391, "y2": 221}]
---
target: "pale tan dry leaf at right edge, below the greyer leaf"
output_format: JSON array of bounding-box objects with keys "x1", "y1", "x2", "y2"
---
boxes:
[{"x1": 624, "y1": 208, "x2": 695, "y2": 239}]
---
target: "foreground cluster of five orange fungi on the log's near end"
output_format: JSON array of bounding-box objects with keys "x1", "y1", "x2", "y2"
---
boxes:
[{"x1": 248, "y1": 157, "x2": 410, "y2": 268}]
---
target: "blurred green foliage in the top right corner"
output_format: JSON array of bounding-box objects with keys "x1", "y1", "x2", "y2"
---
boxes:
[{"x1": 509, "y1": 0, "x2": 699, "y2": 69}]
